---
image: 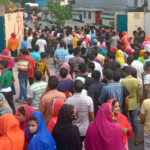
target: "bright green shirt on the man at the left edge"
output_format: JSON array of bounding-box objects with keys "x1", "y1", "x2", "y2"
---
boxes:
[{"x1": 0, "y1": 70, "x2": 14, "y2": 88}]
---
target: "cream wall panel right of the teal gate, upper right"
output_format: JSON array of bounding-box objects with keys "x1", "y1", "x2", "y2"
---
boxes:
[{"x1": 127, "y1": 12, "x2": 144, "y2": 36}]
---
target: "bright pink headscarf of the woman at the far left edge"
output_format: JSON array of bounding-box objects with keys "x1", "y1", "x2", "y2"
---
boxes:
[{"x1": 0, "y1": 49, "x2": 15, "y2": 69}]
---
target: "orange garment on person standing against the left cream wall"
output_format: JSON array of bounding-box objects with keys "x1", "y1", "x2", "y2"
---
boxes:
[{"x1": 7, "y1": 38, "x2": 20, "y2": 51}]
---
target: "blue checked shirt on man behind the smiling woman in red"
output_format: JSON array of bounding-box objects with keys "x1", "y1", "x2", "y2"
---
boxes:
[{"x1": 99, "y1": 81, "x2": 123, "y2": 109}]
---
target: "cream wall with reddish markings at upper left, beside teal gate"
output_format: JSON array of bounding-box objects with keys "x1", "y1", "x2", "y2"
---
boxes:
[{"x1": 4, "y1": 12, "x2": 24, "y2": 46}]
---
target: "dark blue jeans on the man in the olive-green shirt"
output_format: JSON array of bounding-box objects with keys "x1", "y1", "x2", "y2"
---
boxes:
[{"x1": 129, "y1": 110, "x2": 138, "y2": 133}]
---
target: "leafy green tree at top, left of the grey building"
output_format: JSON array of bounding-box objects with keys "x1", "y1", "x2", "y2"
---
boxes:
[{"x1": 47, "y1": 0, "x2": 72, "y2": 24}]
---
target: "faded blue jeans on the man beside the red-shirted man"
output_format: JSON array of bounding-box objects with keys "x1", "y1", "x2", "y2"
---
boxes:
[{"x1": 18, "y1": 72, "x2": 28, "y2": 101}]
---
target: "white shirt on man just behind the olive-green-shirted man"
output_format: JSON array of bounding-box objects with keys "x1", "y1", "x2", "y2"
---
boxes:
[{"x1": 131, "y1": 60, "x2": 144, "y2": 85}]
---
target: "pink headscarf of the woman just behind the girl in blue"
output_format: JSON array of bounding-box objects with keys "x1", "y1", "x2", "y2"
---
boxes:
[{"x1": 15, "y1": 105, "x2": 35, "y2": 130}]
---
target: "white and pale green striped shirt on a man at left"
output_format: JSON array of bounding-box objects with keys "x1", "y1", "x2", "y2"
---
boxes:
[{"x1": 28, "y1": 81, "x2": 47, "y2": 110}]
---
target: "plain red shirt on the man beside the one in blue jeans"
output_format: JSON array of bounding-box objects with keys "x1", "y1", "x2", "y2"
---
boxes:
[{"x1": 25, "y1": 55, "x2": 34, "y2": 78}]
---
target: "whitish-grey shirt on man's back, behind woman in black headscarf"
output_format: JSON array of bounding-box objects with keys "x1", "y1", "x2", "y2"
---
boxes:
[{"x1": 66, "y1": 93, "x2": 94, "y2": 136}]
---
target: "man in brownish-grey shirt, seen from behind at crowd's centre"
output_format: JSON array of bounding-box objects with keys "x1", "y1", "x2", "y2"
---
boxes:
[{"x1": 69, "y1": 47, "x2": 84, "y2": 74}]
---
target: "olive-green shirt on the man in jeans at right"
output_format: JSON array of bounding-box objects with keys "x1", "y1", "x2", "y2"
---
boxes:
[{"x1": 121, "y1": 75, "x2": 141, "y2": 110}]
